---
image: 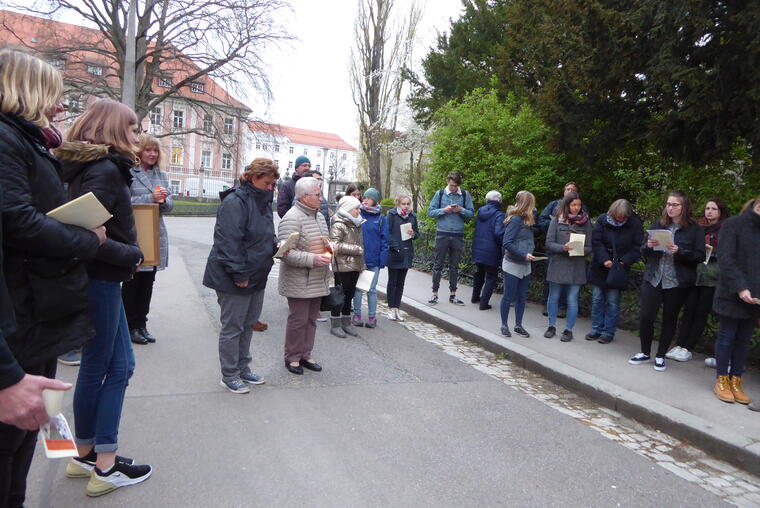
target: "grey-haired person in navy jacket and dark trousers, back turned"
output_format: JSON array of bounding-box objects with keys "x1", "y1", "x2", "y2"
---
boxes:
[{"x1": 471, "y1": 190, "x2": 504, "y2": 310}]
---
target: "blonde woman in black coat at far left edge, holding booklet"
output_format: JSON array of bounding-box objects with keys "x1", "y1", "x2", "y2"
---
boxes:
[{"x1": 0, "y1": 49, "x2": 105, "y2": 506}]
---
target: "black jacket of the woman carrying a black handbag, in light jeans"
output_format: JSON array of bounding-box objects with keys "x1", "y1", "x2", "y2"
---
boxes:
[{"x1": 588, "y1": 213, "x2": 644, "y2": 289}]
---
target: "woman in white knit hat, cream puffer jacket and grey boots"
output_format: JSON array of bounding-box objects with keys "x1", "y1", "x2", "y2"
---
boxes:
[{"x1": 330, "y1": 196, "x2": 364, "y2": 338}]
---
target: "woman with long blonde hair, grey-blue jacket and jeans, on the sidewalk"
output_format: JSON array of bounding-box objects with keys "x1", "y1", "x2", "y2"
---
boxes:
[{"x1": 501, "y1": 191, "x2": 536, "y2": 337}]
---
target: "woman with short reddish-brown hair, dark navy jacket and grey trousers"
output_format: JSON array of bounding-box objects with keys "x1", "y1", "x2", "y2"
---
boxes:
[{"x1": 203, "y1": 158, "x2": 280, "y2": 393}]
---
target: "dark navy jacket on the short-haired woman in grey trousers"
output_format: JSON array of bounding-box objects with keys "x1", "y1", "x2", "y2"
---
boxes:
[{"x1": 203, "y1": 184, "x2": 277, "y2": 295}]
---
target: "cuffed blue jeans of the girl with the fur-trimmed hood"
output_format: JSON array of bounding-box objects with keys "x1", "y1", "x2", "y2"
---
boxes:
[{"x1": 74, "y1": 279, "x2": 135, "y2": 453}]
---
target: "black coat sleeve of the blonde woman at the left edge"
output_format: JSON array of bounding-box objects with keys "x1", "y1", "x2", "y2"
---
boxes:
[{"x1": 0, "y1": 136, "x2": 99, "y2": 259}]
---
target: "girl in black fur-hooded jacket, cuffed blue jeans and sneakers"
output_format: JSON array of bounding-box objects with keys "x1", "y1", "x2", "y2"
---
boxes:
[{"x1": 56, "y1": 99, "x2": 152, "y2": 496}]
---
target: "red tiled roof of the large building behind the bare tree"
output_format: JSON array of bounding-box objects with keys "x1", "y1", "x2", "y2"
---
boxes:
[{"x1": 0, "y1": 10, "x2": 250, "y2": 111}]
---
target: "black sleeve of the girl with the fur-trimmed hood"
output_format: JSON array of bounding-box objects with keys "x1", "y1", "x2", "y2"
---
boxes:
[{"x1": 79, "y1": 167, "x2": 144, "y2": 266}]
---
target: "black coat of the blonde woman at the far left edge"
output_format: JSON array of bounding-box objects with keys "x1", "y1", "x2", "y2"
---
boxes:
[{"x1": 0, "y1": 114, "x2": 98, "y2": 380}]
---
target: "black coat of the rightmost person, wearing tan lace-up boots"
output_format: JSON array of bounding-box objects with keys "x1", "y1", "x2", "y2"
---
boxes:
[{"x1": 713, "y1": 208, "x2": 760, "y2": 319}]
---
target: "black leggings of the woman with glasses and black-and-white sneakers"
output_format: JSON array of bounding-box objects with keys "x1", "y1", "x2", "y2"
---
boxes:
[{"x1": 639, "y1": 282, "x2": 690, "y2": 358}]
